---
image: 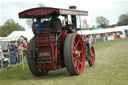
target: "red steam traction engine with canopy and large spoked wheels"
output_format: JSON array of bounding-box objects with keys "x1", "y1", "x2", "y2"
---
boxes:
[{"x1": 19, "y1": 7, "x2": 95, "y2": 76}]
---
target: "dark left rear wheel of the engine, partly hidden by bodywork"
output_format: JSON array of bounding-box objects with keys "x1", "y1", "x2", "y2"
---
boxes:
[{"x1": 27, "y1": 38, "x2": 48, "y2": 76}]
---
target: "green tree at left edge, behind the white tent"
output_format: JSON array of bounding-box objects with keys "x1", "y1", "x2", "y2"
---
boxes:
[{"x1": 0, "y1": 19, "x2": 25, "y2": 37}]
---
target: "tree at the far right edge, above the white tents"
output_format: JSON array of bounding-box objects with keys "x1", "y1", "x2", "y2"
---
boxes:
[{"x1": 117, "y1": 13, "x2": 128, "y2": 26}]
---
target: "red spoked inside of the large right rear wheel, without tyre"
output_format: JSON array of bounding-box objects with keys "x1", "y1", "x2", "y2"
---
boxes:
[{"x1": 73, "y1": 35, "x2": 85, "y2": 73}]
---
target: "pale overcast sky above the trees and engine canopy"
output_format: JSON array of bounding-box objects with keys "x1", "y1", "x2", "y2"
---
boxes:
[{"x1": 0, "y1": 0, "x2": 128, "y2": 30}]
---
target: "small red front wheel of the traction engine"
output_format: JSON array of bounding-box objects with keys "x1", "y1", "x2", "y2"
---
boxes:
[{"x1": 88, "y1": 46, "x2": 95, "y2": 66}]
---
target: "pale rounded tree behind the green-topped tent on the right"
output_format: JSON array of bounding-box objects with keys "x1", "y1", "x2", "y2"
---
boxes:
[{"x1": 96, "y1": 16, "x2": 107, "y2": 28}]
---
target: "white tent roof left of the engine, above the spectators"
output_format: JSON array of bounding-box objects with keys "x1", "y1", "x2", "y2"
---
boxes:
[{"x1": 2, "y1": 31, "x2": 34, "y2": 41}]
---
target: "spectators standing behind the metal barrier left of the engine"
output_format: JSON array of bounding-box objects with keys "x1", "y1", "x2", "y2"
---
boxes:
[{"x1": 8, "y1": 40, "x2": 27, "y2": 66}]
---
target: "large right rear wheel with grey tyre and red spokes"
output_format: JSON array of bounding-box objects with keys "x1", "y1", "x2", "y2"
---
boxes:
[{"x1": 64, "y1": 34, "x2": 85, "y2": 75}]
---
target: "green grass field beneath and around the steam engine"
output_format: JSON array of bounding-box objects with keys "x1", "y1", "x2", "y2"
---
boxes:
[{"x1": 0, "y1": 38, "x2": 128, "y2": 85}]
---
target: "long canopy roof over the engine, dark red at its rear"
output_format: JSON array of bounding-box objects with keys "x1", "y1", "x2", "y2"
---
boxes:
[{"x1": 19, "y1": 7, "x2": 88, "y2": 18}]
